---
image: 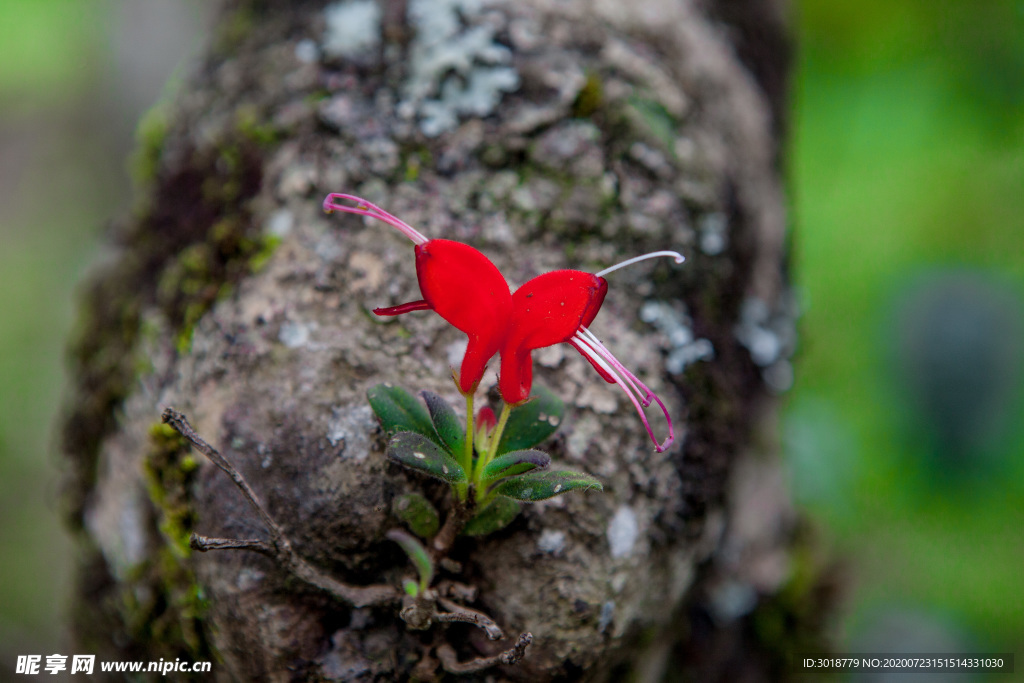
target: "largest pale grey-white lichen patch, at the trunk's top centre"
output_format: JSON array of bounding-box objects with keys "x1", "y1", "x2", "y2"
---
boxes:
[{"x1": 398, "y1": 0, "x2": 519, "y2": 137}]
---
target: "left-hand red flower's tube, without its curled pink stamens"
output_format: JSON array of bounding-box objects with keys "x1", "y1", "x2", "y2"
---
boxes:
[{"x1": 416, "y1": 240, "x2": 512, "y2": 392}]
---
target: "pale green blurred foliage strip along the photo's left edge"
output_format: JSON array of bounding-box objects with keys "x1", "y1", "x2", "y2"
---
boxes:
[{"x1": 0, "y1": 0, "x2": 119, "y2": 663}]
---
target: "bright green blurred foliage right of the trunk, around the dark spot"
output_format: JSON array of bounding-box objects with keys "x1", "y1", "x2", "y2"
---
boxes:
[{"x1": 784, "y1": 0, "x2": 1024, "y2": 663}]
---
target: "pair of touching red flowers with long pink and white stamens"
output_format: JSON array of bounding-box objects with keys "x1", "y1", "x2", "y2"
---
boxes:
[{"x1": 324, "y1": 194, "x2": 683, "y2": 452}]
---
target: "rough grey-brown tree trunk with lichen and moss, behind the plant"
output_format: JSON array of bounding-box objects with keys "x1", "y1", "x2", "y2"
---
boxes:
[{"x1": 65, "y1": 0, "x2": 821, "y2": 681}]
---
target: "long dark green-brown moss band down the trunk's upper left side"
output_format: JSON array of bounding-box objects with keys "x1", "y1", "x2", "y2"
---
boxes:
[{"x1": 63, "y1": 122, "x2": 273, "y2": 522}]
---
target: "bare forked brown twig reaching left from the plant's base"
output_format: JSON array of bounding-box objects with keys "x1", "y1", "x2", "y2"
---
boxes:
[{"x1": 163, "y1": 408, "x2": 400, "y2": 607}]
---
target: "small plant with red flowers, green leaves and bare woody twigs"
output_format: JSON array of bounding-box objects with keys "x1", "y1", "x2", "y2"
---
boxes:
[{"x1": 164, "y1": 194, "x2": 683, "y2": 674}]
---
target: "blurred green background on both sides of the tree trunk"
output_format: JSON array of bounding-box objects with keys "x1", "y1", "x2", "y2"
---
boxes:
[{"x1": 0, "y1": 0, "x2": 1024, "y2": 681}]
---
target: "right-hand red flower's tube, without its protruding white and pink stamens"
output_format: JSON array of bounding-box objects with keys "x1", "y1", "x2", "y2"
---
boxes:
[{"x1": 499, "y1": 270, "x2": 608, "y2": 403}]
